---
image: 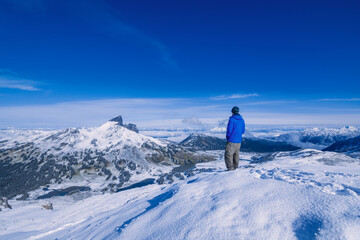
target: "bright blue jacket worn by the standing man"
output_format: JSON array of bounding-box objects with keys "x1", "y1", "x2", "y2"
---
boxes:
[{"x1": 226, "y1": 115, "x2": 245, "y2": 143}]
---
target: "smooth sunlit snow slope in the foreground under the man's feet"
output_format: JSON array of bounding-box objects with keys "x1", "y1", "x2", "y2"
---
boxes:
[{"x1": 0, "y1": 149, "x2": 360, "y2": 240}]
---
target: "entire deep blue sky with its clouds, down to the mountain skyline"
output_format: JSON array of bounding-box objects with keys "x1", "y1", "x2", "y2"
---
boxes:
[{"x1": 0, "y1": 0, "x2": 360, "y2": 128}]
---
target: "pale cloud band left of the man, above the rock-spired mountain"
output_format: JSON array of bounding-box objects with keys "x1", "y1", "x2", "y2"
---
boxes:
[{"x1": 0, "y1": 98, "x2": 230, "y2": 128}]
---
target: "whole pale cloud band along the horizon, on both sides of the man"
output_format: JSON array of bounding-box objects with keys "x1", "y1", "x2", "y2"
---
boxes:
[{"x1": 0, "y1": 98, "x2": 360, "y2": 129}]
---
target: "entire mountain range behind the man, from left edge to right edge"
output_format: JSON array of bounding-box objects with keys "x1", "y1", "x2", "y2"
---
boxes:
[{"x1": 0, "y1": 116, "x2": 360, "y2": 199}]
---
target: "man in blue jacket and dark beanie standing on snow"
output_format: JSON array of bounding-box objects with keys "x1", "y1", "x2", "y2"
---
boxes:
[{"x1": 225, "y1": 106, "x2": 245, "y2": 171}]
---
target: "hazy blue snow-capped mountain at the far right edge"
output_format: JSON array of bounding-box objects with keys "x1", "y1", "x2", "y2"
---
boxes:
[{"x1": 271, "y1": 126, "x2": 360, "y2": 149}]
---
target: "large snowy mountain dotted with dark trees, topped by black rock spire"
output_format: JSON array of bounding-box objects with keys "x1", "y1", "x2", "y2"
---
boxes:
[{"x1": 0, "y1": 117, "x2": 214, "y2": 199}]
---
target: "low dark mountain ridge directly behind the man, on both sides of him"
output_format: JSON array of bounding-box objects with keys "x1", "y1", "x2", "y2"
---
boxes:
[{"x1": 180, "y1": 134, "x2": 299, "y2": 152}]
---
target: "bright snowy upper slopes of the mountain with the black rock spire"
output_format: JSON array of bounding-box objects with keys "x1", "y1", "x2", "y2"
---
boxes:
[{"x1": 0, "y1": 121, "x2": 166, "y2": 152}]
